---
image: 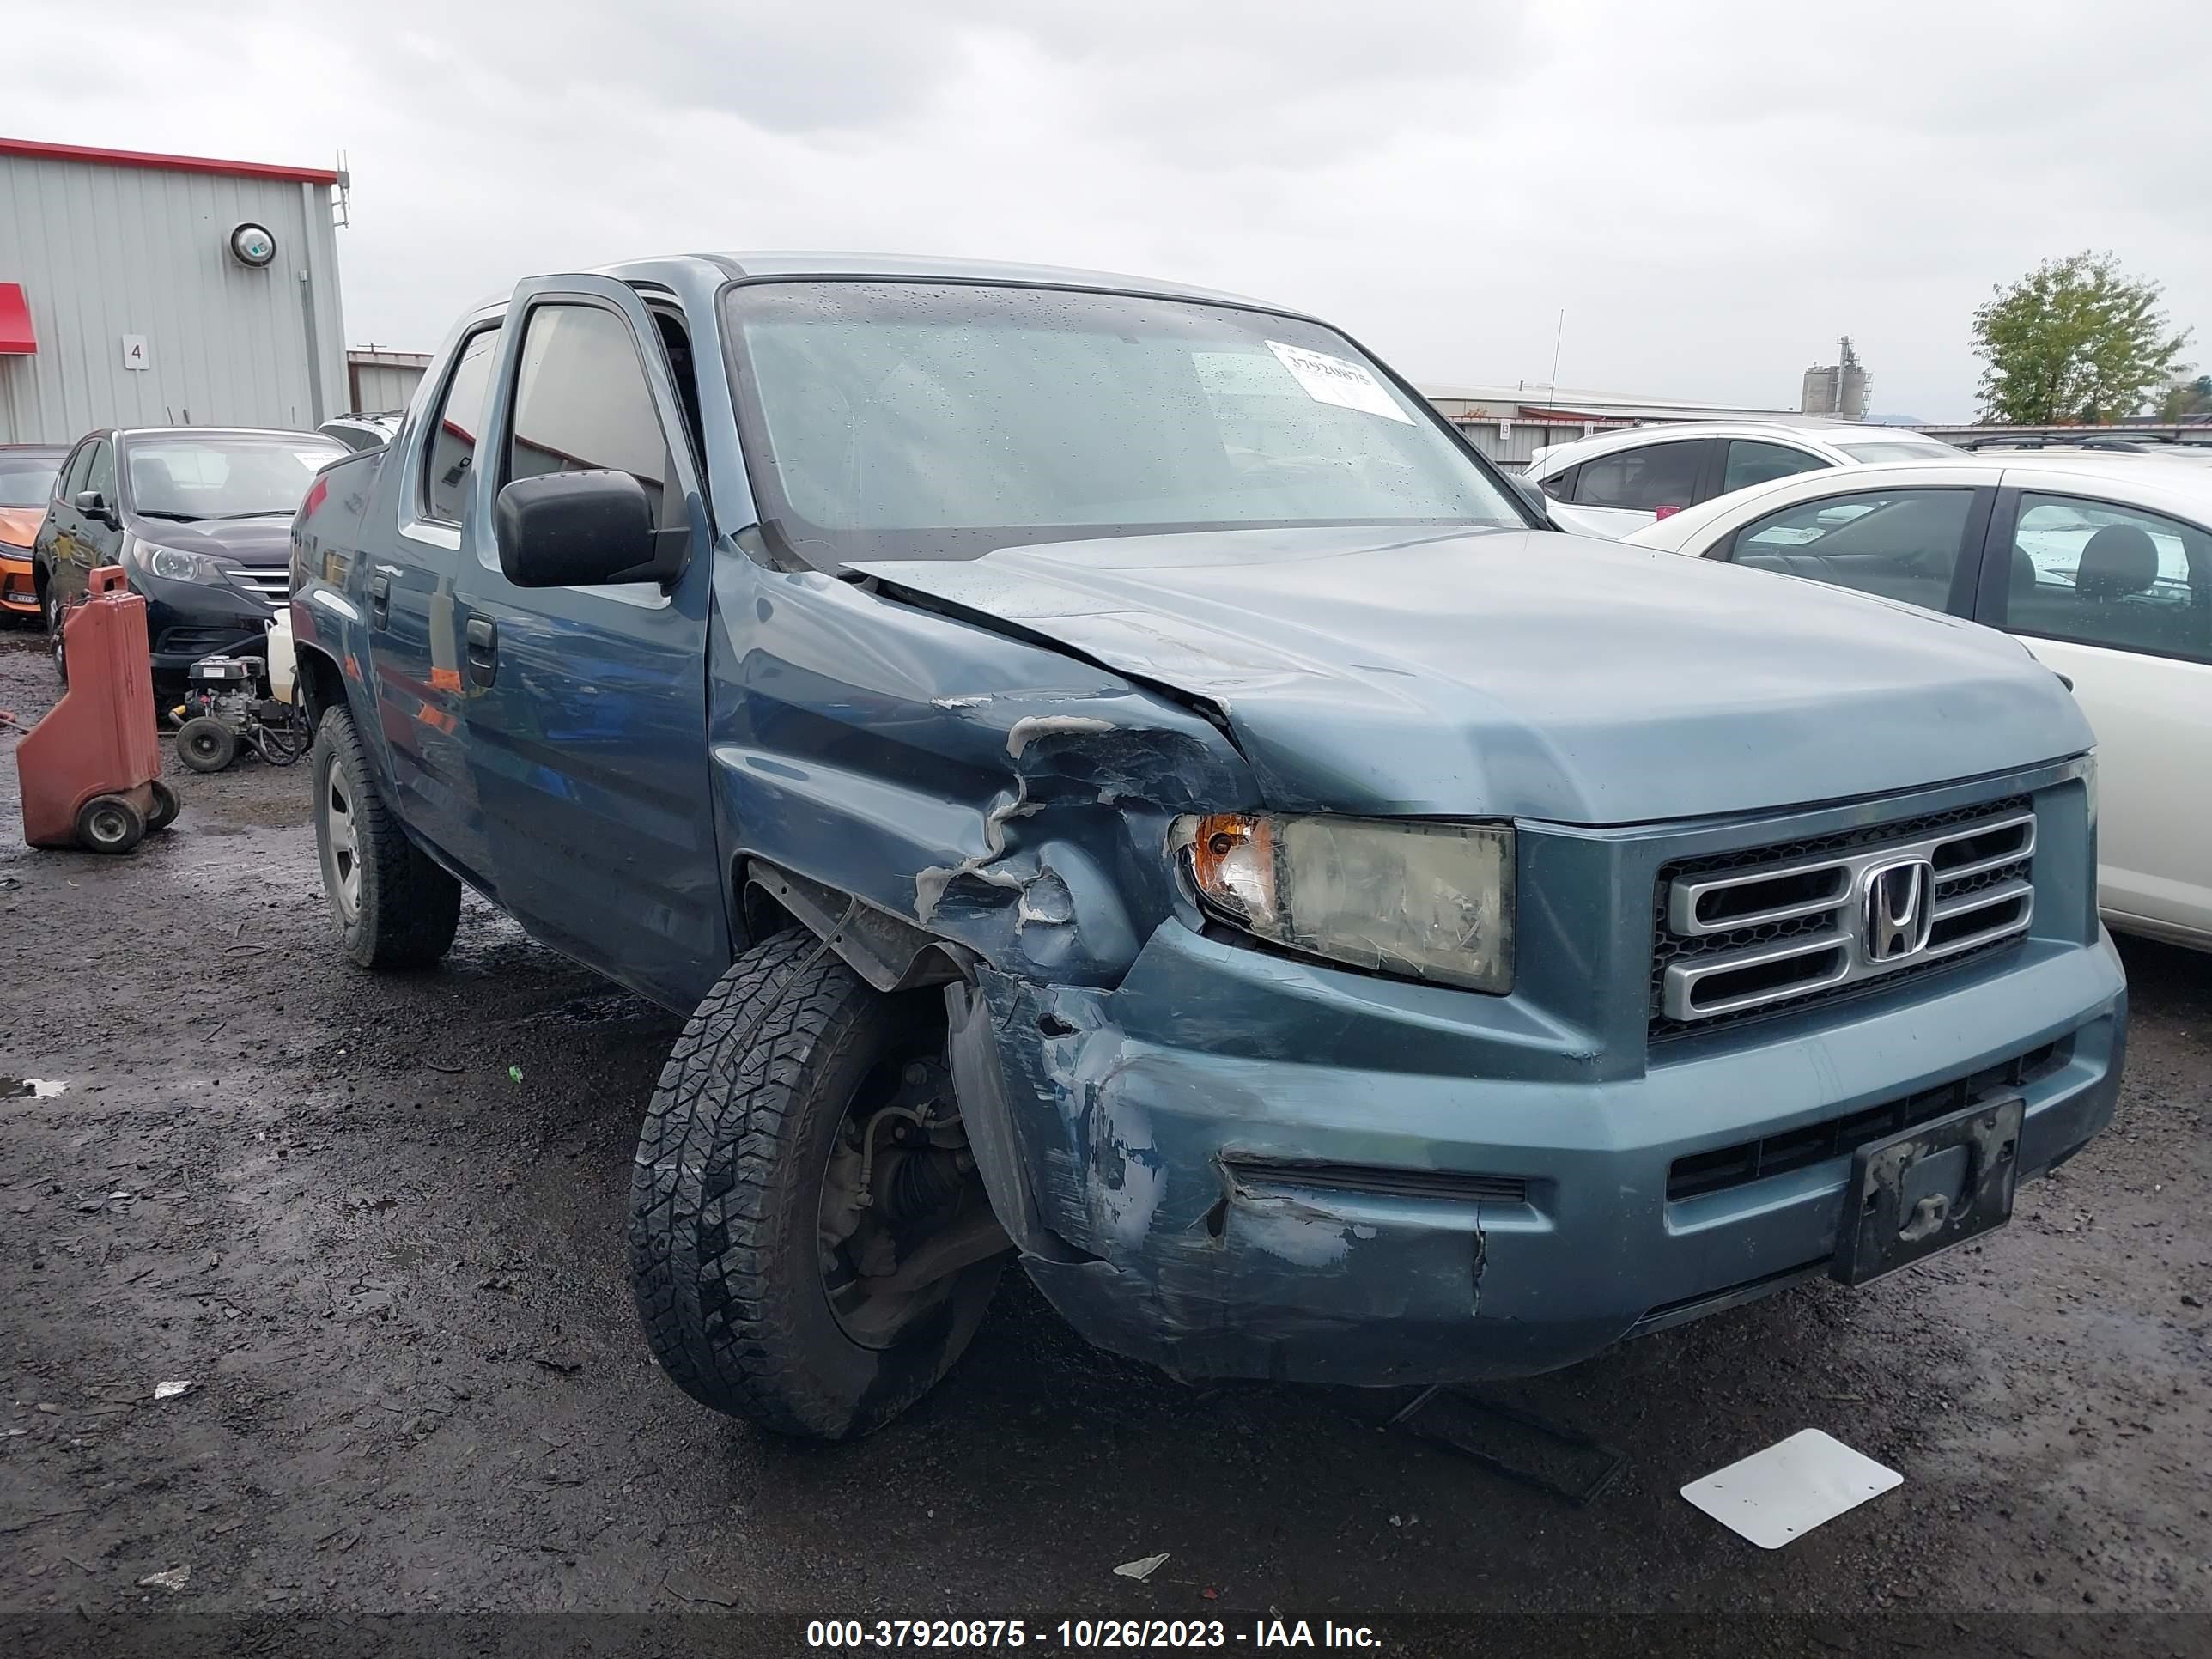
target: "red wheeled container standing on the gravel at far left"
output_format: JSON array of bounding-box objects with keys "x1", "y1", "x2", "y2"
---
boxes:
[{"x1": 15, "y1": 566, "x2": 177, "y2": 852}]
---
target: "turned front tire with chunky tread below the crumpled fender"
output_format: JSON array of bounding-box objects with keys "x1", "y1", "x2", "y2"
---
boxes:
[{"x1": 630, "y1": 931, "x2": 1002, "y2": 1440}]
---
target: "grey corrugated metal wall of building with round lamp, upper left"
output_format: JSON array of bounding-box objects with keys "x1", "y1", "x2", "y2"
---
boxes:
[{"x1": 0, "y1": 155, "x2": 345, "y2": 442}]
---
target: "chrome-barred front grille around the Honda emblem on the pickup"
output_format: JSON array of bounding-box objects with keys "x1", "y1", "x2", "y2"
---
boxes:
[{"x1": 1650, "y1": 796, "x2": 2035, "y2": 1037}]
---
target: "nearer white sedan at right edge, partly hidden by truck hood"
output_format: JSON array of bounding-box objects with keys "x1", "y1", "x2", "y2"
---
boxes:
[{"x1": 1626, "y1": 453, "x2": 2212, "y2": 949}]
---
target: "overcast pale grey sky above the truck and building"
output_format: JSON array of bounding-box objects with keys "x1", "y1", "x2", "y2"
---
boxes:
[{"x1": 0, "y1": 0, "x2": 2212, "y2": 418}]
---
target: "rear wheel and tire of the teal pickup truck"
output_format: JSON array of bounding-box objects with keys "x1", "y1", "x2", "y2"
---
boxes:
[{"x1": 314, "y1": 708, "x2": 460, "y2": 971}]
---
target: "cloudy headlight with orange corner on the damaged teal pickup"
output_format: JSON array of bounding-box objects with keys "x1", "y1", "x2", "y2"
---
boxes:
[{"x1": 1170, "y1": 811, "x2": 1513, "y2": 994}]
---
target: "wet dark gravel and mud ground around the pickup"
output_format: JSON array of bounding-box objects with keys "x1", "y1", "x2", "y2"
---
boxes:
[{"x1": 0, "y1": 633, "x2": 2212, "y2": 1652}]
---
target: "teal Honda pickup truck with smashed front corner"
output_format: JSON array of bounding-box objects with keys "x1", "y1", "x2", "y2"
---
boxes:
[{"x1": 292, "y1": 254, "x2": 2126, "y2": 1437}]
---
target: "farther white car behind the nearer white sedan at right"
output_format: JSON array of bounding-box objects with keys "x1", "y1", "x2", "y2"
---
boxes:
[{"x1": 1522, "y1": 420, "x2": 1960, "y2": 538}]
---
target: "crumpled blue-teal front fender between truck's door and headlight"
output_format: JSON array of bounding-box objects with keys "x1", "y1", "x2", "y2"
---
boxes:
[{"x1": 710, "y1": 557, "x2": 1256, "y2": 987}]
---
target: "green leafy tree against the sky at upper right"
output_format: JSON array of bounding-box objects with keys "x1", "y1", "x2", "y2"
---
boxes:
[{"x1": 1973, "y1": 252, "x2": 2190, "y2": 427}]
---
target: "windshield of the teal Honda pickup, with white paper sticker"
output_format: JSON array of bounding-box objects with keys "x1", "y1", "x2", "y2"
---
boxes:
[{"x1": 728, "y1": 283, "x2": 1528, "y2": 566}]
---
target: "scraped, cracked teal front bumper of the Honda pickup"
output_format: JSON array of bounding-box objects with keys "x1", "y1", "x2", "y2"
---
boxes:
[{"x1": 953, "y1": 922, "x2": 2126, "y2": 1385}]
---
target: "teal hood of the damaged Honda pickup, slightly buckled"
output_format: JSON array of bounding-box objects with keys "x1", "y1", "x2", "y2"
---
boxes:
[{"x1": 854, "y1": 529, "x2": 2094, "y2": 825}]
